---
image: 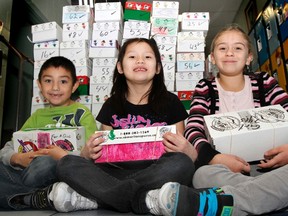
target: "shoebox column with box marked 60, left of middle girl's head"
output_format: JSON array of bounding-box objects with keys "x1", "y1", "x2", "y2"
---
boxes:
[{"x1": 89, "y1": 2, "x2": 123, "y2": 126}]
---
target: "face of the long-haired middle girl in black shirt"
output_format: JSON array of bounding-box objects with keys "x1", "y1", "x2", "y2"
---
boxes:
[{"x1": 117, "y1": 42, "x2": 160, "y2": 84}]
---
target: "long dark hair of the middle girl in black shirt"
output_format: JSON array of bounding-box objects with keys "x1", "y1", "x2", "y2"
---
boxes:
[{"x1": 111, "y1": 38, "x2": 168, "y2": 114}]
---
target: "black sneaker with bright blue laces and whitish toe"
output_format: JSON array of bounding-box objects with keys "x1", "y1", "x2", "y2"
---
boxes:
[{"x1": 158, "y1": 182, "x2": 233, "y2": 216}]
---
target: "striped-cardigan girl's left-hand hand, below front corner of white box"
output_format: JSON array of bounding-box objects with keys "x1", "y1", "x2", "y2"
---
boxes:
[{"x1": 209, "y1": 154, "x2": 251, "y2": 173}]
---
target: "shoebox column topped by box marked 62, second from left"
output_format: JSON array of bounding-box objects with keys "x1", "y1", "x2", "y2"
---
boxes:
[{"x1": 60, "y1": 5, "x2": 93, "y2": 106}]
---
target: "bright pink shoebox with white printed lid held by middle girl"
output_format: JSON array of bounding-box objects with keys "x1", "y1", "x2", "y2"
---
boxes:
[{"x1": 95, "y1": 125, "x2": 176, "y2": 163}]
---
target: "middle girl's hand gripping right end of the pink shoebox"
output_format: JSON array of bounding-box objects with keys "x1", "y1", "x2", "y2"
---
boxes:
[{"x1": 163, "y1": 132, "x2": 198, "y2": 161}]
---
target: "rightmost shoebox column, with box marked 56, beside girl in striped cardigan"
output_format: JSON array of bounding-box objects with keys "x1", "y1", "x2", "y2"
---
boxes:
[{"x1": 176, "y1": 12, "x2": 209, "y2": 110}]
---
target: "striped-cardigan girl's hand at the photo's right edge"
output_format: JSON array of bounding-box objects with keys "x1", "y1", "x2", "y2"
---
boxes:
[{"x1": 258, "y1": 144, "x2": 288, "y2": 168}]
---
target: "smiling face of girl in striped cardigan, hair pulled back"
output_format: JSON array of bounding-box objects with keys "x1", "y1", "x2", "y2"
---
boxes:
[{"x1": 211, "y1": 30, "x2": 253, "y2": 76}]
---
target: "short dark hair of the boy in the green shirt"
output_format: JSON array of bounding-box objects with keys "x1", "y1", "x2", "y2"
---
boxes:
[{"x1": 38, "y1": 56, "x2": 77, "y2": 85}]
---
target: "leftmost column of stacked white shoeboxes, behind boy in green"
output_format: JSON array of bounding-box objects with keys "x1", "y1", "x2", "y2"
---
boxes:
[{"x1": 31, "y1": 21, "x2": 62, "y2": 114}]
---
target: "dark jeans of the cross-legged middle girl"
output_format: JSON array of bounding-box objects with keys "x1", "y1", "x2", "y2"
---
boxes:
[{"x1": 57, "y1": 153, "x2": 195, "y2": 214}]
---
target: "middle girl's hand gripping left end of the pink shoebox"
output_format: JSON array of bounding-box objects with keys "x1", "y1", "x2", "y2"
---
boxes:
[{"x1": 81, "y1": 132, "x2": 105, "y2": 160}]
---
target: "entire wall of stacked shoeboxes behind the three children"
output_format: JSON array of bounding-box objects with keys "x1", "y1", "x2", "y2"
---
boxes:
[{"x1": 32, "y1": 1, "x2": 213, "y2": 125}]
